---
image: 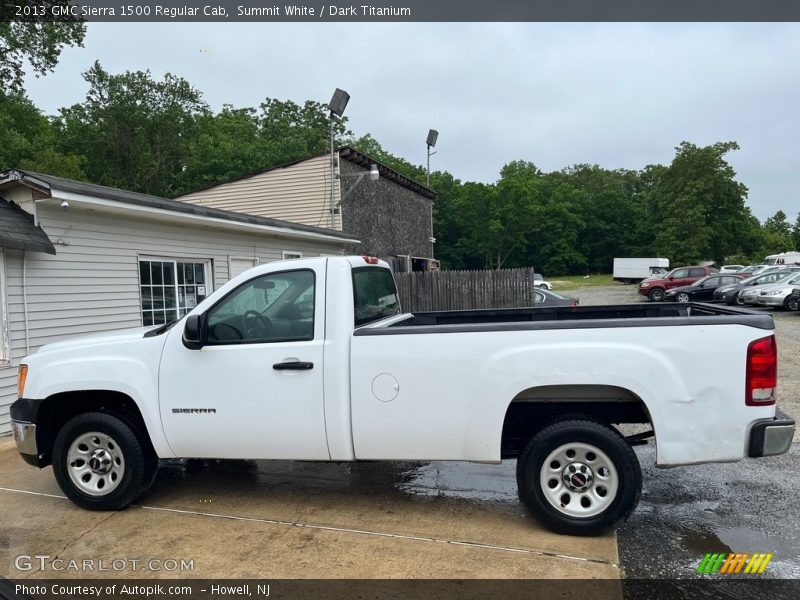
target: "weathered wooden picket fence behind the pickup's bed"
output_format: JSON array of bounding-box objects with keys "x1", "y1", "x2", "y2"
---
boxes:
[{"x1": 394, "y1": 267, "x2": 533, "y2": 312}]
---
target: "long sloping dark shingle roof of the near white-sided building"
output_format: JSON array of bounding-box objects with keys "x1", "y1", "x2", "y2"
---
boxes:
[{"x1": 0, "y1": 170, "x2": 353, "y2": 242}]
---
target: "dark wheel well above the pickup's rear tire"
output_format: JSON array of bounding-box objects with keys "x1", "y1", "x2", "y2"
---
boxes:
[{"x1": 500, "y1": 385, "x2": 652, "y2": 458}]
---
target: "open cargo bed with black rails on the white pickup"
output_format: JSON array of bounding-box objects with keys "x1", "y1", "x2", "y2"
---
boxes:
[{"x1": 354, "y1": 302, "x2": 774, "y2": 335}]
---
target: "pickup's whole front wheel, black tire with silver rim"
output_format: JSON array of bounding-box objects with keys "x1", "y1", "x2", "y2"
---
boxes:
[{"x1": 53, "y1": 412, "x2": 158, "y2": 510}]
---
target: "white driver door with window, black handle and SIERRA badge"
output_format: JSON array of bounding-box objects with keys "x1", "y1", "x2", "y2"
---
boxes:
[{"x1": 159, "y1": 269, "x2": 330, "y2": 460}]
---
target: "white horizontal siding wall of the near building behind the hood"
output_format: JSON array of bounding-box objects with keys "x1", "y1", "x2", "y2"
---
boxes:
[{"x1": 0, "y1": 203, "x2": 341, "y2": 435}]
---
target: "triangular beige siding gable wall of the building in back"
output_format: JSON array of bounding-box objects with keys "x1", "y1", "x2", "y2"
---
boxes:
[{"x1": 176, "y1": 155, "x2": 342, "y2": 231}]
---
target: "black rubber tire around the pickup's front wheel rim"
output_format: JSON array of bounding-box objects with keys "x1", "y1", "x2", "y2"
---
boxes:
[{"x1": 53, "y1": 412, "x2": 158, "y2": 510}]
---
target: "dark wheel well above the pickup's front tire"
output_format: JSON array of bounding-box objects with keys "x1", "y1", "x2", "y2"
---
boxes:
[{"x1": 36, "y1": 390, "x2": 155, "y2": 467}]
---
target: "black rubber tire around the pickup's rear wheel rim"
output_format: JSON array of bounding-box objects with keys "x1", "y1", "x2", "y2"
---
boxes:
[{"x1": 517, "y1": 418, "x2": 642, "y2": 535}]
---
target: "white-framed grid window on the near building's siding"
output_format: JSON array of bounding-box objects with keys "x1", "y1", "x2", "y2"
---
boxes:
[{"x1": 139, "y1": 258, "x2": 211, "y2": 325}]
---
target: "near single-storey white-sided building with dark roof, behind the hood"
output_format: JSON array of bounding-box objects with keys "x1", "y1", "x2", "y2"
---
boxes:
[{"x1": 0, "y1": 170, "x2": 357, "y2": 435}]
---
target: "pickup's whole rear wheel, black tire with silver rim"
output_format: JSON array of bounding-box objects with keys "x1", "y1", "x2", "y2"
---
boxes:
[{"x1": 517, "y1": 419, "x2": 642, "y2": 535}]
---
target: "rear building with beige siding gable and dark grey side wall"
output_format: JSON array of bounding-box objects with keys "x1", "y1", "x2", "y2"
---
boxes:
[{"x1": 176, "y1": 146, "x2": 438, "y2": 271}]
